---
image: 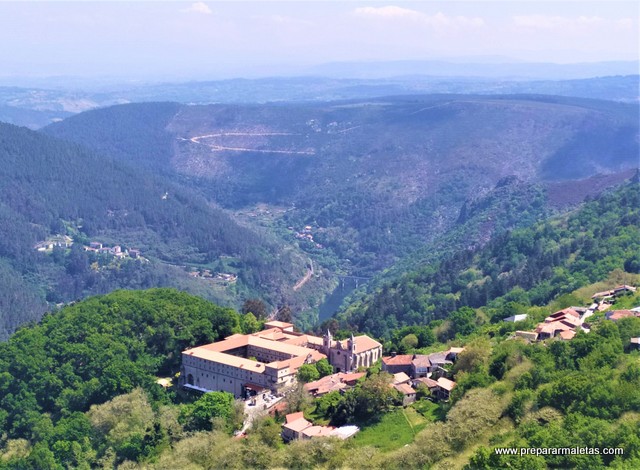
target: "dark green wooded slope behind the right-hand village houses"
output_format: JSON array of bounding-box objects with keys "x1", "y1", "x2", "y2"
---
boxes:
[{"x1": 338, "y1": 177, "x2": 640, "y2": 336}]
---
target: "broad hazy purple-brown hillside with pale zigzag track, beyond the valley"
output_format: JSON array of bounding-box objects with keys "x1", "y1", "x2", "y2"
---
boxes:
[{"x1": 44, "y1": 95, "x2": 639, "y2": 277}]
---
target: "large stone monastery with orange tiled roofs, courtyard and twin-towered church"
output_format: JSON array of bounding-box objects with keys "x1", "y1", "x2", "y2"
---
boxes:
[{"x1": 180, "y1": 321, "x2": 382, "y2": 398}]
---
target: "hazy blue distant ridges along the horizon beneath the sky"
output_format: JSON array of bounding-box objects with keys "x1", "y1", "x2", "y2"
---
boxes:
[{"x1": 0, "y1": 71, "x2": 640, "y2": 129}]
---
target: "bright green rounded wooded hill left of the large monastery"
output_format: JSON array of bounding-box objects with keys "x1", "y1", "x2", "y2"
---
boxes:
[{"x1": 0, "y1": 289, "x2": 241, "y2": 470}]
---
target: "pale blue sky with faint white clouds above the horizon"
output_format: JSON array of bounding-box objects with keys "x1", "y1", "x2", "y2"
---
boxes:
[{"x1": 0, "y1": 0, "x2": 640, "y2": 79}]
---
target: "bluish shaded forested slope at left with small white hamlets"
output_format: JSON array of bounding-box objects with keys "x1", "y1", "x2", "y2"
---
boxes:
[{"x1": 0, "y1": 124, "x2": 305, "y2": 339}]
